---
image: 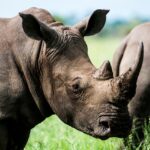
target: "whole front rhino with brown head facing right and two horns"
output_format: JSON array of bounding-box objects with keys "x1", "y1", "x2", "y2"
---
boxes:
[{"x1": 0, "y1": 8, "x2": 143, "y2": 150}]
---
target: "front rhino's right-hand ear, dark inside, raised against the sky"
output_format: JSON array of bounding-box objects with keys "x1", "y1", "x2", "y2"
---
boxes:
[{"x1": 74, "y1": 9, "x2": 109, "y2": 36}]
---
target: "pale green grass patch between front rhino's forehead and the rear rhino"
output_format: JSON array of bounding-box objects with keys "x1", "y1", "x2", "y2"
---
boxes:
[{"x1": 86, "y1": 37, "x2": 121, "y2": 67}]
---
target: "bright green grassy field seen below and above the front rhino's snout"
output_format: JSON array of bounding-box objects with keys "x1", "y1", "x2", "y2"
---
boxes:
[{"x1": 25, "y1": 37, "x2": 123, "y2": 150}]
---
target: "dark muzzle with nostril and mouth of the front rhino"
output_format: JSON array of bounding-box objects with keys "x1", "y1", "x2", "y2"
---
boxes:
[{"x1": 82, "y1": 113, "x2": 132, "y2": 140}]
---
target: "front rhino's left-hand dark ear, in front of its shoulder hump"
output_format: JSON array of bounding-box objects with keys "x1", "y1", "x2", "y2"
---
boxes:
[{"x1": 19, "y1": 13, "x2": 57, "y2": 41}]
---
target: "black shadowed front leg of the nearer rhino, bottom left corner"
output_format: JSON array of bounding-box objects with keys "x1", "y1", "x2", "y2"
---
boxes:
[{"x1": 0, "y1": 120, "x2": 30, "y2": 150}]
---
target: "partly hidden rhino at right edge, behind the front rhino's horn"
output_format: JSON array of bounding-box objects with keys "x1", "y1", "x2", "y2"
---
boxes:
[{"x1": 113, "y1": 23, "x2": 150, "y2": 145}]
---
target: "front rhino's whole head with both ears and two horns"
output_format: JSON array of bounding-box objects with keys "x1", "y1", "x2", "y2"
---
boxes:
[{"x1": 20, "y1": 10, "x2": 143, "y2": 139}]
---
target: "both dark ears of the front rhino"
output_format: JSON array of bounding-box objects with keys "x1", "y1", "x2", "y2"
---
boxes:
[{"x1": 19, "y1": 9, "x2": 109, "y2": 41}]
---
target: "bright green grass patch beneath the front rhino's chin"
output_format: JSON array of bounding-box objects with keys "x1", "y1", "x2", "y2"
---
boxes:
[{"x1": 26, "y1": 115, "x2": 122, "y2": 150}]
